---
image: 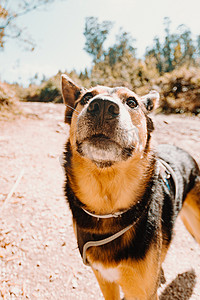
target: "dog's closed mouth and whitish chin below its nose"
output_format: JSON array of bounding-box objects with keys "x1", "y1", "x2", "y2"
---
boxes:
[{"x1": 76, "y1": 134, "x2": 135, "y2": 167}]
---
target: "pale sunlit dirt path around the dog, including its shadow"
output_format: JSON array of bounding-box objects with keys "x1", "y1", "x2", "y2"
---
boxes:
[{"x1": 0, "y1": 103, "x2": 200, "y2": 300}]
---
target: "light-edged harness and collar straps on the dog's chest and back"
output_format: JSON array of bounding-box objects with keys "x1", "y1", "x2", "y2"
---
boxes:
[{"x1": 75, "y1": 158, "x2": 178, "y2": 266}]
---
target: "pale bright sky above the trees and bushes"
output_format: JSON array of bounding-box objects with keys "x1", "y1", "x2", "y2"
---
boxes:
[{"x1": 0, "y1": 0, "x2": 200, "y2": 86}]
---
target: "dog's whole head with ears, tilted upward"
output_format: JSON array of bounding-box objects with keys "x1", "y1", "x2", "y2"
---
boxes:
[{"x1": 62, "y1": 75, "x2": 159, "y2": 168}]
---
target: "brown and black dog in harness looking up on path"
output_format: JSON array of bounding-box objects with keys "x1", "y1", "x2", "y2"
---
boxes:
[{"x1": 62, "y1": 75, "x2": 200, "y2": 300}]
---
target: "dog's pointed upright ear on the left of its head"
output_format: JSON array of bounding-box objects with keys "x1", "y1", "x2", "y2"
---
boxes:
[{"x1": 62, "y1": 74, "x2": 82, "y2": 124}]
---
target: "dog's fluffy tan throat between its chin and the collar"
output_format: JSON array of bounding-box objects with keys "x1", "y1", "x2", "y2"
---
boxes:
[{"x1": 70, "y1": 148, "x2": 153, "y2": 214}]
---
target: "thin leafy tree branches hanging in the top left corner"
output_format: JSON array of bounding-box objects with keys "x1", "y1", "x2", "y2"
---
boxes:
[{"x1": 0, "y1": 0, "x2": 60, "y2": 50}]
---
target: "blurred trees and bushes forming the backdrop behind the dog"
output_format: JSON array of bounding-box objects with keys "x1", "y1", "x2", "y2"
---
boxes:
[{"x1": 5, "y1": 17, "x2": 200, "y2": 115}]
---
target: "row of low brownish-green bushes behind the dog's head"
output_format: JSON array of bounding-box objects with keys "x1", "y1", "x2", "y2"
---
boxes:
[{"x1": 21, "y1": 63, "x2": 200, "y2": 115}]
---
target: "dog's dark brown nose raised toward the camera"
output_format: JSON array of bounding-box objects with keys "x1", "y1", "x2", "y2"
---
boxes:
[{"x1": 87, "y1": 98, "x2": 119, "y2": 120}]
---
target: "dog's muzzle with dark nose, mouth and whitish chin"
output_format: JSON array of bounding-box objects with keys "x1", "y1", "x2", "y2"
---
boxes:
[{"x1": 77, "y1": 96, "x2": 139, "y2": 166}]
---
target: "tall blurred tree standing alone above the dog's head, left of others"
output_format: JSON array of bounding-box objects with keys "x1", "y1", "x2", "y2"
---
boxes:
[{"x1": 83, "y1": 17, "x2": 113, "y2": 64}]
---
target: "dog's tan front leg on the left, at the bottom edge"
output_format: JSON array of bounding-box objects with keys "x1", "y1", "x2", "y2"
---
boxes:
[{"x1": 92, "y1": 268, "x2": 120, "y2": 300}]
